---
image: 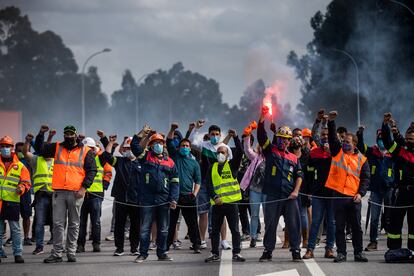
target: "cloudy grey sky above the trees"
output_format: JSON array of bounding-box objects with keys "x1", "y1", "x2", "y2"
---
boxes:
[{"x1": 0, "y1": 0, "x2": 330, "y2": 106}]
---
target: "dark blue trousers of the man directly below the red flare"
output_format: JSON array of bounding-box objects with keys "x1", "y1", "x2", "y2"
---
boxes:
[{"x1": 263, "y1": 195, "x2": 301, "y2": 253}]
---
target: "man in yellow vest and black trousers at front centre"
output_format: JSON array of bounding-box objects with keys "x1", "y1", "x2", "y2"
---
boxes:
[{"x1": 205, "y1": 131, "x2": 245, "y2": 263}]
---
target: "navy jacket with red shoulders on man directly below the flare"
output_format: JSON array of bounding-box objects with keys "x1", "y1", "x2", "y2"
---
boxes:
[{"x1": 257, "y1": 122, "x2": 303, "y2": 198}]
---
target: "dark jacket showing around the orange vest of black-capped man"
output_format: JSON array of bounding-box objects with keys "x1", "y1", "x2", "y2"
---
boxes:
[{"x1": 34, "y1": 132, "x2": 98, "y2": 189}]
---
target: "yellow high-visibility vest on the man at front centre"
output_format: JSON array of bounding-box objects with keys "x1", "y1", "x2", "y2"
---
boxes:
[{"x1": 210, "y1": 162, "x2": 242, "y2": 205}]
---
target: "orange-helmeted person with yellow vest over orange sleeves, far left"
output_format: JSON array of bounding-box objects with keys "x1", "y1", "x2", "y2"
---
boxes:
[{"x1": 0, "y1": 136, "x2": 31, "y2": 263}]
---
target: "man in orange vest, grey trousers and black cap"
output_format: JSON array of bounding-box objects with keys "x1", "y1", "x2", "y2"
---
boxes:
[{"x1": 34, "y1": 125, "x2": 97, "y2": 263}]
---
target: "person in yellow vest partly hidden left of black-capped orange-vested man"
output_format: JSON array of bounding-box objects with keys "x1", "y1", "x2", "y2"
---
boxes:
[{"x1": 23, "y1": 133, "x2": 54, "y2": 255}]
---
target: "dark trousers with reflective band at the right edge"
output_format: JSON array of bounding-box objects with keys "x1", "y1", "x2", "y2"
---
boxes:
[{"x1": 387, "y1": 187, "x2": 414, "y2": 250}]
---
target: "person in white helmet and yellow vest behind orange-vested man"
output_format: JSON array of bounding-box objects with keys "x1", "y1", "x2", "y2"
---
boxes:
[{"x1": 76, "y1": 137, "x2": 112, "y2": 253}]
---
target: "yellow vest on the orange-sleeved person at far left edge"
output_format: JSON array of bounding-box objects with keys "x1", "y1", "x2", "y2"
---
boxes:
[{"x1": 0, "y1": 162, "x2": 24, "y2": 202}]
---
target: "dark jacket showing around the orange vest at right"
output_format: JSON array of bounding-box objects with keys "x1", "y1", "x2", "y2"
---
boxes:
[{"x1": 328, "y1": 121, "x2": 370, "y2": 197}]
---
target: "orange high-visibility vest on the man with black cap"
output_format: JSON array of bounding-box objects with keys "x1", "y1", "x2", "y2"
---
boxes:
[{"x1": 52, "y1": 143, "x2": 90, "y2": 191}]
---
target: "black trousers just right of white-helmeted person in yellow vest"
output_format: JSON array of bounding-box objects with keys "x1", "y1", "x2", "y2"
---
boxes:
[{"x1": 114, "y1": 203, "x2": 140, "y2": 253}]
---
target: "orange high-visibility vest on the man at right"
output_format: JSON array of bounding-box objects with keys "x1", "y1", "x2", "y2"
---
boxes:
[{"x1": 325, "y1": 149, "x2": 367, "y2": 196}]
